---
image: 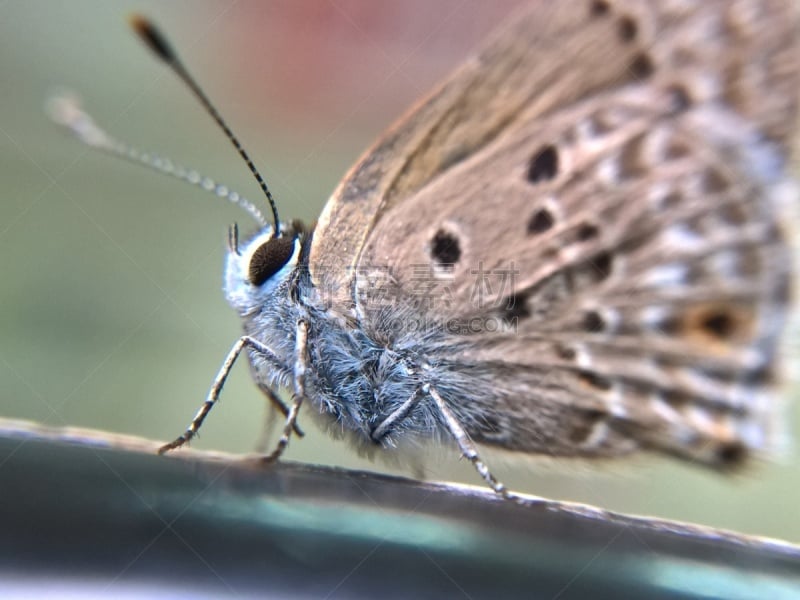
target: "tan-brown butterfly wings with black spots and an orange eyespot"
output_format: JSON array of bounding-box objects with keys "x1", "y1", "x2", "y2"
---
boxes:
[{"x1": 312, "y1": 0, "x2": 800, "y2": 464}]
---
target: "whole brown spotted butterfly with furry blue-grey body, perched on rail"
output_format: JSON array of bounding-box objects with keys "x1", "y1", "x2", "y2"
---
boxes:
[{"x1": 53, "y1": 0, "x2": 800, "y2": 494}]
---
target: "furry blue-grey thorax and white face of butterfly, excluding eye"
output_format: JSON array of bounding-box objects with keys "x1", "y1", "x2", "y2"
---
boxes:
[{"x1": 225, "y1": 226, "x2": 441, "y2": 444}]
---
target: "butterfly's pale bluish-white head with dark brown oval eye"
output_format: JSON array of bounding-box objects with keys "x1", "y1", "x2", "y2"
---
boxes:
[{"x1": 225, "y1": 225, "x2": 301, "y2": 315}]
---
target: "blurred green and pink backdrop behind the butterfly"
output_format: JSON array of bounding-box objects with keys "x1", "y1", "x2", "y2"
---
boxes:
[{"x1": 0, "y1": 0, "x2": 800, "y2": 542}]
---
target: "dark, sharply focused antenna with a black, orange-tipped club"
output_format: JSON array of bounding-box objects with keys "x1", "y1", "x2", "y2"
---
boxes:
[{"x1": 130, "y1": 15, "x2": 280, "y2": 239}]
